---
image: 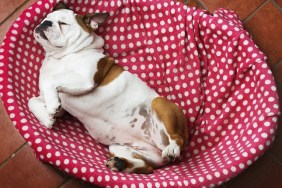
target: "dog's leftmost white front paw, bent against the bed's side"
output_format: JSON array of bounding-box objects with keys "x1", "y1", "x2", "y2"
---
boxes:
[{"x1": 28, "y1": 96, "x2": 55, "y2": 129}]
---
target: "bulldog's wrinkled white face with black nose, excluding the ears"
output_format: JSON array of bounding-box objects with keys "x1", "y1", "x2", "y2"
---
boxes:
[{"x1": 34, "y1": 9, "x2": 82, "y2": 50}]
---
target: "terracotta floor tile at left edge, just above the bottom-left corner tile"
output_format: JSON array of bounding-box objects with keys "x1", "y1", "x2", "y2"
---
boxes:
[{"x1": 0, "y1": 99, "x2": 25, "y2": 164}]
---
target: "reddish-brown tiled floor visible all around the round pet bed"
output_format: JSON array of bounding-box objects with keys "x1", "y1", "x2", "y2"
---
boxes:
[{"x1": 0, "y1": 0, "x2": 282, "y2": 188}]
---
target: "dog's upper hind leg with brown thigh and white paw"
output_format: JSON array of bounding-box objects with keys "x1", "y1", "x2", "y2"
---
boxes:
[{"x1": 152, "y1": 97, "x2": 188, "y2": 161}]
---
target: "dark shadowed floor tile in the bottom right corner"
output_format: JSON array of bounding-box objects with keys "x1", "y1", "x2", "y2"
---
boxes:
[{"x1": 225, "y1": 152, "x2": 282, "y2": 188}]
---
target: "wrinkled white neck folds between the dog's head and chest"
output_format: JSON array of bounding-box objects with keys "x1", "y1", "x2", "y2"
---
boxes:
[{"x1": 45, "y1": 33, "x2": 104, "y2": 59}]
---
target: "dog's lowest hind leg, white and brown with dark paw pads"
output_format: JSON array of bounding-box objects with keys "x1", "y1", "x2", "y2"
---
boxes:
[{"x1": 106, "y1": 145, "x2": 166, "y2": 174}]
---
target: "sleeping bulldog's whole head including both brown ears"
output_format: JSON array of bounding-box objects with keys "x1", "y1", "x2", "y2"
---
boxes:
[{"x1": 34, "y1": 2, "x2": 108, "y2": 51}]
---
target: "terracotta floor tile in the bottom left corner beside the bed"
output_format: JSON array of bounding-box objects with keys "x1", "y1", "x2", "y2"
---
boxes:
[{"x1": 0, "y1": 145, "x2": 63, "y2": 188}]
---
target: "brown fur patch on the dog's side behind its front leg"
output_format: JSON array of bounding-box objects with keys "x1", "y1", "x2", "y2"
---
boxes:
[{"x1": 94, "y1": 57, "x2": 124, "y2": 86}]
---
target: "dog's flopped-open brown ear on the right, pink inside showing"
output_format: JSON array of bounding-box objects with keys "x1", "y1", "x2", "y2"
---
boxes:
[{"x1": 83, "y1": 13, "x2": 109, "y2": 31}]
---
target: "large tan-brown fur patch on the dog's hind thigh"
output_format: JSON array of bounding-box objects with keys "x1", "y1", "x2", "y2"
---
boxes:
[{"x1": 152, "y1": 97, "x2": 188, "y2": 150}]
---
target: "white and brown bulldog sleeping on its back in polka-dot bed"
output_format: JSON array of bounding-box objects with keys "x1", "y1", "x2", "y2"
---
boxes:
[{"x1": 28, "y1": 2, "x2": 188, "y2": 174}]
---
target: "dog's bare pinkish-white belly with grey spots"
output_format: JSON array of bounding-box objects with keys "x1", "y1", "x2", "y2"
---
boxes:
[{"x1": 60, "y1": 72, "x2": 164, "y2": 147}]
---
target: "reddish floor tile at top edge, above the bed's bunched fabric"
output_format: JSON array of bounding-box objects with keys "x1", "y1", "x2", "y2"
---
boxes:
[{"x1": 198, "y1": 0, "x2": 264, "y2": 20}]
